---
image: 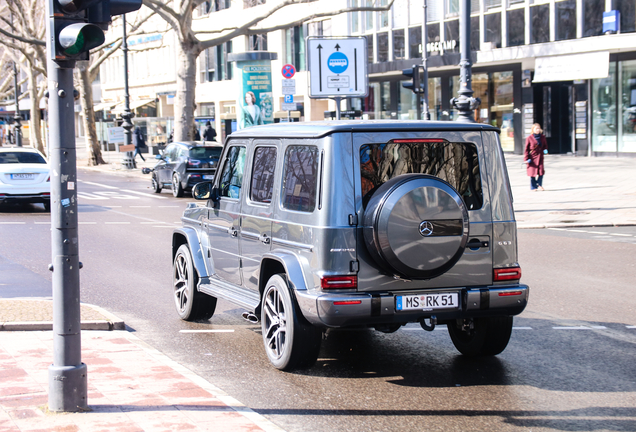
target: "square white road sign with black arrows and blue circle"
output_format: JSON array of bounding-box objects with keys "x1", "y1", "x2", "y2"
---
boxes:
[{"x1": 307, "y1": 37, "x2": 368, "y2": 98}]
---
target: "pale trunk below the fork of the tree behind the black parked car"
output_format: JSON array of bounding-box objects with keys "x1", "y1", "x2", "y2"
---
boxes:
[{"x1": 174, "y1": 42, "x2": 200, "y2": 141}]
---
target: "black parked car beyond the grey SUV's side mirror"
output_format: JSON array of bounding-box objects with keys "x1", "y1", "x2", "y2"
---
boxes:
[{"x1": 148, "y1": 141, "x2": 223, "y2": 197}]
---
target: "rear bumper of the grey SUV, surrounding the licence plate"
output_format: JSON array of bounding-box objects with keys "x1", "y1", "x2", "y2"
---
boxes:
[{"x1": 296, "y1": 284, "x2": 530, "y2": 327}]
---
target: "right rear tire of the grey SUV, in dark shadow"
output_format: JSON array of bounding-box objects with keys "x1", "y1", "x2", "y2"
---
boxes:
[{"x1": 448, "y1": 316, "x2": 513, "y2": 357}]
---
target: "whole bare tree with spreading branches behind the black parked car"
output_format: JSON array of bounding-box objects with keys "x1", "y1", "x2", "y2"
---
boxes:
[{"x1": 143, "y1": 0, "x2": 394, "y2": 140}]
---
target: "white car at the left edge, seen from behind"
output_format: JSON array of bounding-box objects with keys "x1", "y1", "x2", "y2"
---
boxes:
[{"x1": 0, "y1": 147, "x2": 51, "y2": 211}]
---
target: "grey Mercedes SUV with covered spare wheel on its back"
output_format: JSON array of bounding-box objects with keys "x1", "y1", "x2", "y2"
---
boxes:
[{"x1": 172, "y1": 121, "x2": 529, "y2": 370}]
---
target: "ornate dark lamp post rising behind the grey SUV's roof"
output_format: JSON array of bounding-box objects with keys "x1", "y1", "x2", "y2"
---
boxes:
[{"x1": 451, "y1": 0, "x2": 481, "y2": 123}]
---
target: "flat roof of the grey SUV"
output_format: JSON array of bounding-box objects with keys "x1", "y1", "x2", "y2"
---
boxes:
[{"x1": 231, "y1": 120, "x2": 499, "y2": 138}]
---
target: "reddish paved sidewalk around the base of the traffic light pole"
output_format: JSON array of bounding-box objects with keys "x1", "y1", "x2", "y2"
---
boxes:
[{"x1": 0, "y1": 331, "x2": 282, "y2": 432}]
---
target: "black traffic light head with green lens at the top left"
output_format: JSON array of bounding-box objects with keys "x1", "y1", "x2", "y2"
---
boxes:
[{"x1": 49, "y1": 0, "x2": 141, "y2": 61}]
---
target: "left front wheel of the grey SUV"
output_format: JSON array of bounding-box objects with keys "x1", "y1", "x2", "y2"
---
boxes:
[{"x1": 172, "y1": 244, "x2": 216, "y2": 321}]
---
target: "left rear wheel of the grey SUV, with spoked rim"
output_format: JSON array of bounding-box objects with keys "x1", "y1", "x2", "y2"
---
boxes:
[{"x1": 261, "y1": 274, "x2": 322, "y2": 371}]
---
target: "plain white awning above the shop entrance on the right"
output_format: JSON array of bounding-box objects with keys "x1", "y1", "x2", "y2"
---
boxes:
[{"x1": 532, "y1": 51, "x2": 609, "y2": 82}]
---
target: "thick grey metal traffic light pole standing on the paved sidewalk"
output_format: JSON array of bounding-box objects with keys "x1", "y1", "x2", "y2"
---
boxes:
[{"x1": 46, "y1": 2, "x2": 88, "y2": 412}]
